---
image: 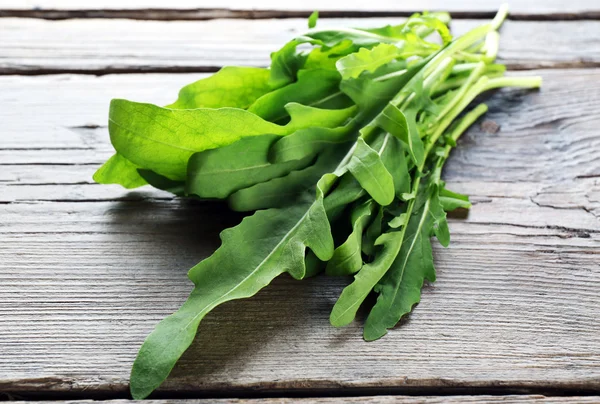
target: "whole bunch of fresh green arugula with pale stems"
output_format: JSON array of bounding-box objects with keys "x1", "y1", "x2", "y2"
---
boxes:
[{"x1": 94, "y1": 8, "x2": 541, "y2": 399}]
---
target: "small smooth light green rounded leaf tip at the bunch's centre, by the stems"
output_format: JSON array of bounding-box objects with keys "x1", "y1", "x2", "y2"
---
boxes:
[{"x1": 347, "y1": 138, "x2": 395, "y2": 206}]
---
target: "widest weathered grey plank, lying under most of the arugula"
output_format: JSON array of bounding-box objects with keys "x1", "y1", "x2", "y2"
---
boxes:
[{"x1": 0, "y1": 69, "x2": 600, "y2": 402}]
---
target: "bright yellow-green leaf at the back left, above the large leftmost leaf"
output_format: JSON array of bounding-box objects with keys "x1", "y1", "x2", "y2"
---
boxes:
[{"x1": 167, "y1": 66, "x2": 271, "y2": 109}]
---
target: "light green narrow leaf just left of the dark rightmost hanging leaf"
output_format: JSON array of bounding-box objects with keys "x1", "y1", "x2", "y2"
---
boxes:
[{"x1": 329, "y1": 232, "x2": 402, "y2": 327}]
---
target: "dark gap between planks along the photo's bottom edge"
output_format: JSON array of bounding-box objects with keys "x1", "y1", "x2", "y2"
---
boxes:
[{"x1": 0, "y1": 378, "x2": 600, "y2": 404}]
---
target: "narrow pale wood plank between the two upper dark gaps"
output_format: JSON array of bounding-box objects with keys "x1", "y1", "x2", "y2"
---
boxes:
[{"x1": 0, "y1": 18, "x2": 600, "y2": 74}]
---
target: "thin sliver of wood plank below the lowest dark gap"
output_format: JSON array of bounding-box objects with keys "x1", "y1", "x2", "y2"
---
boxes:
[{"x1": 13, "y1": 395, "x2": 600, "y2": 404}]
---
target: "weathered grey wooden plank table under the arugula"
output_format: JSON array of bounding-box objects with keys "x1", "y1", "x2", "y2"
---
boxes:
[{"x1": 0, "y1": 0, "x2": 600, "y2": 403}]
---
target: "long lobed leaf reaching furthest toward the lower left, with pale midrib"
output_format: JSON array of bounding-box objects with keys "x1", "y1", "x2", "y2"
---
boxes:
[{"x1": 130, "y1": 193, "x2": 333, "y2": 399}]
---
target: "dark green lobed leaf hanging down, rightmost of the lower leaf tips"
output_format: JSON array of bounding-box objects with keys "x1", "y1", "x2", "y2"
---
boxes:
[{"x1": 364, "y1": 178, "x2": 450, "y2": 341}]
